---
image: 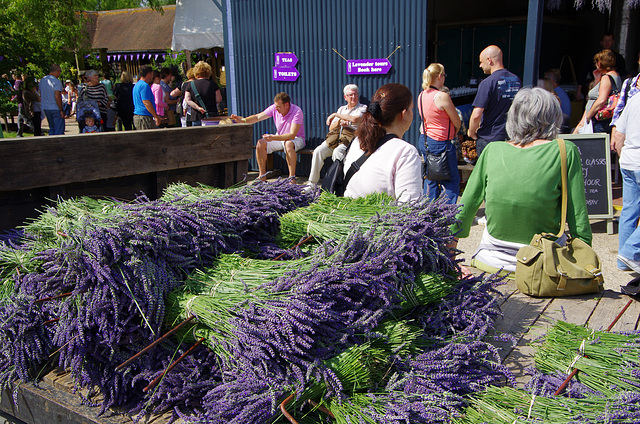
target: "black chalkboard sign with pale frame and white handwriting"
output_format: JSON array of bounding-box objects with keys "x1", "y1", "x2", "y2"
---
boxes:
[{"x1": 558, "y1": 133, "x2": 613, "y2": 219}]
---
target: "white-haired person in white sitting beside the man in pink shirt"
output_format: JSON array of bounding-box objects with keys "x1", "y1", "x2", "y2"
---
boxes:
[{"x1": 305, "y1": 84, "x2": 367, "y2": 190}]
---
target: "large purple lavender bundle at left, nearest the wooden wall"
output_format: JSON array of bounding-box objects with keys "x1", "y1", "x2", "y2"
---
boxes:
[{"x1": 0, "y1": 183, "x2": 310, "y2": 410}]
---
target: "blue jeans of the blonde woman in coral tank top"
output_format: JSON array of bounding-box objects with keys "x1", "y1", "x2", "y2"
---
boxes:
[{"x1": 419, "y1": 134, "x2": 460, "y2": 205}]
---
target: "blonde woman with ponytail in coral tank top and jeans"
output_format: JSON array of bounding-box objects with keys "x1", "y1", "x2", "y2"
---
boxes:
[{"x1": 418, "y1": 63, "x2": 462, "y2": 204}]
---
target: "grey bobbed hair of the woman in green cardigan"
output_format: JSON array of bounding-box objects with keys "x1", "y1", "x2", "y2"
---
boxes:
[{"x1": 506, "y1": 87, "x2": 562, "y2": 146}]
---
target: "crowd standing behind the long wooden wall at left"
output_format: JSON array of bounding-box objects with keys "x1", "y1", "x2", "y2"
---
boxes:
[{"x1": 5, "y1": 61, "x2": 222, "y2": 137}]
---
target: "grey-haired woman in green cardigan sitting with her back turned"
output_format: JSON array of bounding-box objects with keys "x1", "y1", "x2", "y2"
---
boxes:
[{"x1": 453, "y1": 88, "x2": 591, "y2": 274}]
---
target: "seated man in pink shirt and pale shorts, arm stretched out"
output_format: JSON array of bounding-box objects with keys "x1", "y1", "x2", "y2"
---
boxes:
[{"x1": 231, "y1": 93, "x2": 305, "y2": 181}]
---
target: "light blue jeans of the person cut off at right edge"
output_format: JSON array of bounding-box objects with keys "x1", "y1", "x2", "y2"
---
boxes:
[{"x1": 618, "y1": 169, "x2": 640, "y2": 269}]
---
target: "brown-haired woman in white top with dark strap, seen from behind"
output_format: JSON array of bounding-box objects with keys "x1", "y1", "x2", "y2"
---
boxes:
[{"x1": 344, "y1": 83, "x2": 422, "y2": 202}]
